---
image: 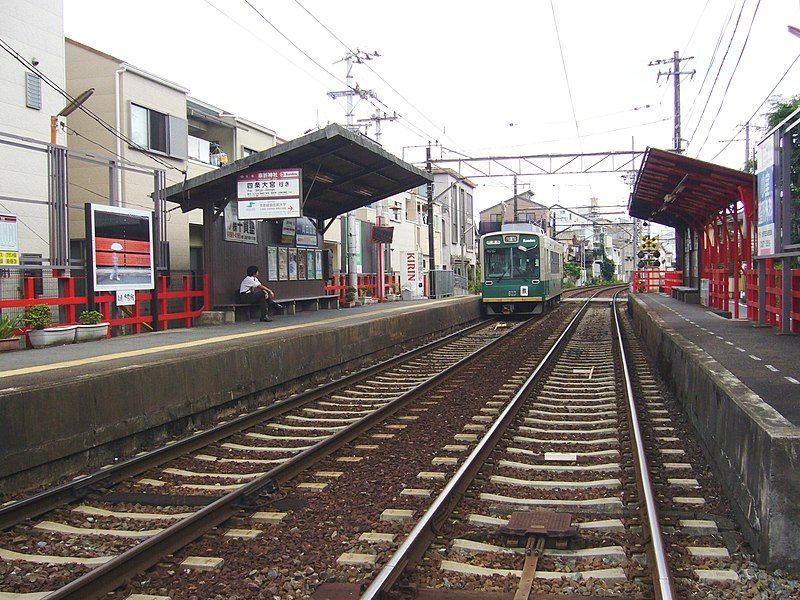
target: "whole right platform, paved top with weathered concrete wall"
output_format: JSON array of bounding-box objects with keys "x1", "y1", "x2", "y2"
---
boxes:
[{"x1": 628, "y1": 294, "x2": 800, "y2": 570}]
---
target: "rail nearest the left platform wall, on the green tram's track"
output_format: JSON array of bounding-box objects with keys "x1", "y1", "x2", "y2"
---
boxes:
[{"x1": 0, "y1": 321, "x2": 486, "y2": 531}]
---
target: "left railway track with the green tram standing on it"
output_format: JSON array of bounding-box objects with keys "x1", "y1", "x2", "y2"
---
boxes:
[{"x1": 0, "y1": 316, "x2": 524, "y2": 598}]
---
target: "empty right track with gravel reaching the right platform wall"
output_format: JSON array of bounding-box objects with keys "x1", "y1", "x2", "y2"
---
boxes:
[{"x1": 362, "y1": 292, "x2": 798, "y2": 600}]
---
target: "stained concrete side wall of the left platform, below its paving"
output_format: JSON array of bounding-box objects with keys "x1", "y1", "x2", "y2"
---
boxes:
[{"x1": 0, "y1": 297, "x2": 479, "y2": 492}]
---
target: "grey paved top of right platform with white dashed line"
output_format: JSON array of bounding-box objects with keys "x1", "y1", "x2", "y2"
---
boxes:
[{"x1": 638, "y1": 294, "x2": 800, "y2": 425}]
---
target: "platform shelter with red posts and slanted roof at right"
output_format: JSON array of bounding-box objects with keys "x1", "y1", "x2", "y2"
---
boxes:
[{"x1": 628, "y1": 148, "x2": 756, "y2": 318}]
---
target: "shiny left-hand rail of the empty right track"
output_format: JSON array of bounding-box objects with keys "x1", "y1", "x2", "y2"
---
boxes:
[{"x1": 361, "y1": 291, "x2": 599, "y2": 600}]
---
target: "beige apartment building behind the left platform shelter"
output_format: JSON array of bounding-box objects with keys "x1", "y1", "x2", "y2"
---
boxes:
[{"x1": 65, "y1": 39, "x2": 281, "y2": 270}]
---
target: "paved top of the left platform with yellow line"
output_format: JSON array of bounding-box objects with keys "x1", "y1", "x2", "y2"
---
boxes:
[{"x1": 0, "y1": 298, "x2": 472, "y2": 394}]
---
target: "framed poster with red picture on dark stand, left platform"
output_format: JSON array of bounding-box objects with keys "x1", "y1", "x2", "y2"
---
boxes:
[{"x1": 86, "y1": 204, "x2": 155, "y2": 292}]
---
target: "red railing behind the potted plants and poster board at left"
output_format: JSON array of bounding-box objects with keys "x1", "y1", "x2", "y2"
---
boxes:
[{"x1": 0, "y1": 275, "x2": 210, "y2": 334}]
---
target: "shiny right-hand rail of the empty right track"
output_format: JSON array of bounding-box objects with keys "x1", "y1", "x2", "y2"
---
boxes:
[{"x1": 611, "y1": 292, "x2": 675, "y2": 600}]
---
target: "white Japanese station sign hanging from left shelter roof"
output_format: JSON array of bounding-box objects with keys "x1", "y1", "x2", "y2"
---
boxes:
[{"x1": 236, "y1": 169, "x2": 303, "y2": 219}]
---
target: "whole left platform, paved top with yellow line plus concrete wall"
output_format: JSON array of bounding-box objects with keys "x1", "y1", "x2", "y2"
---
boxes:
[{"x1": 0, "y1": 296, "x2": 480, "y2": 496}]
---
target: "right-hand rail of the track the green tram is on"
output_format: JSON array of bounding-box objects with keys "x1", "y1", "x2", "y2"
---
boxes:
[{"x1": 43, "y1": 312, "x2": 534, "y2": 600}]
